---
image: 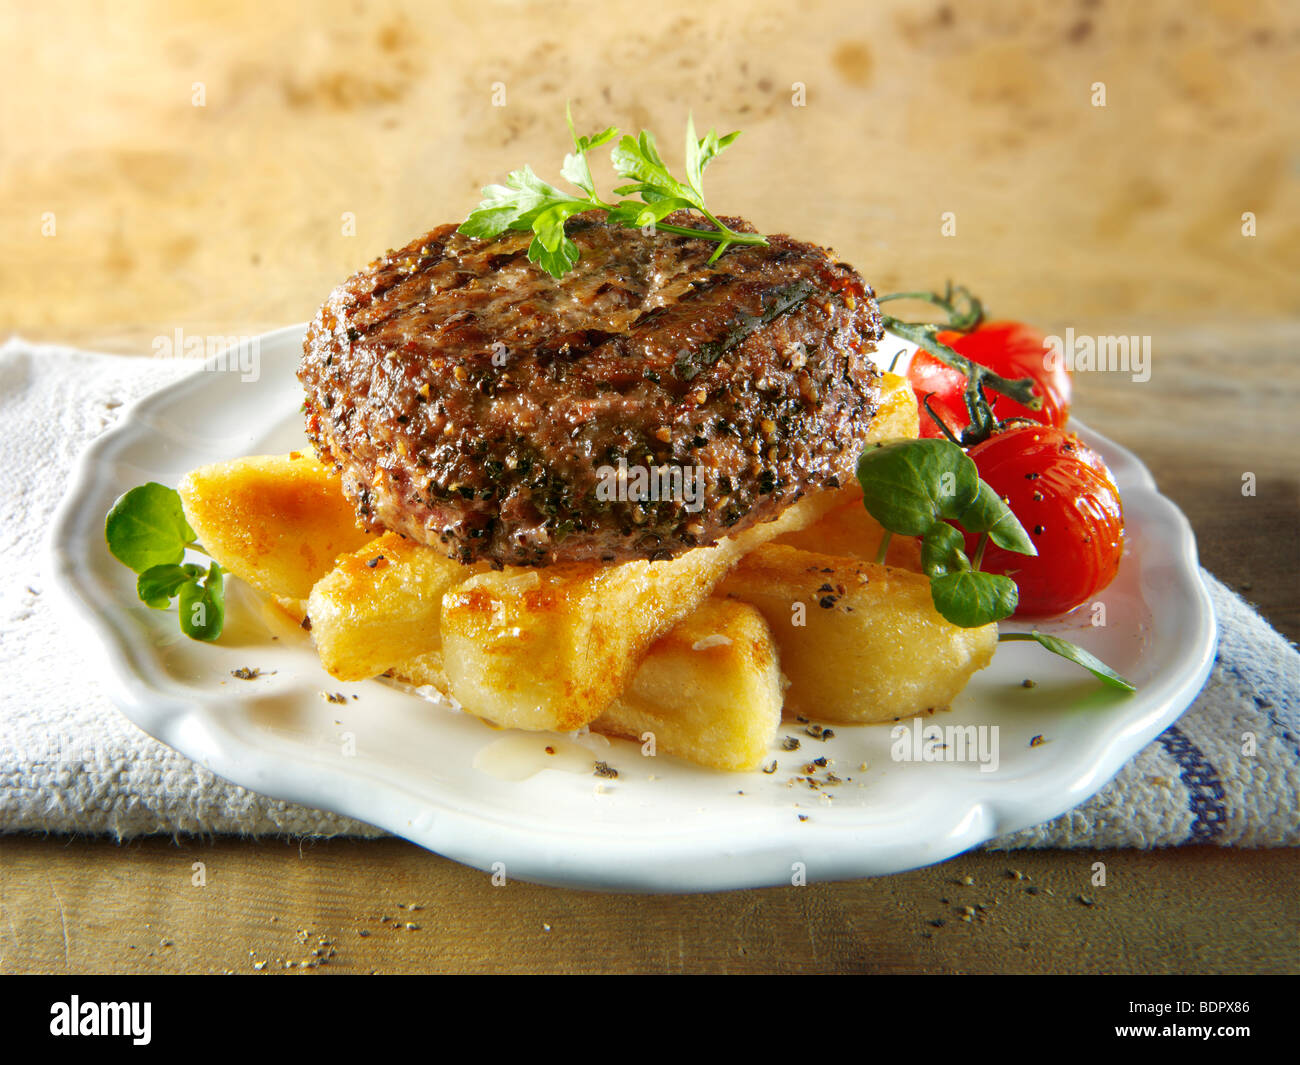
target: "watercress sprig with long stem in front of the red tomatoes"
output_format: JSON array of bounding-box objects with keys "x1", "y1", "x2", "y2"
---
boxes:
[{"x1": 858, "y1": 440, "x2": 1136, "y2": 692}]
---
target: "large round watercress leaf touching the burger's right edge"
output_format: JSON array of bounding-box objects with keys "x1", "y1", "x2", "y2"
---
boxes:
[{"x1": 858, "y1": 440, "x2": 979, "y2": 536}]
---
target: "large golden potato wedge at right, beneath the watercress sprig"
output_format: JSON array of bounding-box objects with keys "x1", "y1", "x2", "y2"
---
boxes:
[{"x1": 719, "y1": 544, "x2": 997, "y2": 724}]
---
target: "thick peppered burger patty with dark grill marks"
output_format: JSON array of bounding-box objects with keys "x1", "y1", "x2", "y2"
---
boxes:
[{"x1": 298, "y1": 212, "x2": 883, "y2": 566}]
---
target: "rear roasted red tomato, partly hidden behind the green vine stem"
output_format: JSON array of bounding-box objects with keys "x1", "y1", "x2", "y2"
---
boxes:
[{"x1": 907, "y1": 321, "x2": 1070, "y2": 437}]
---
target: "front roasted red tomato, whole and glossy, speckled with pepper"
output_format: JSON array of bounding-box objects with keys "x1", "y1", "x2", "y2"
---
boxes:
[{"x1": 966, "y1": 425, "x2": 1125, "y2": 618}]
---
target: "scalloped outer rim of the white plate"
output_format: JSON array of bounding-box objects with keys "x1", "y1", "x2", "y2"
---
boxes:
[{"x1": 47, "y1": 325, "x2": 1217, "y2": 892}]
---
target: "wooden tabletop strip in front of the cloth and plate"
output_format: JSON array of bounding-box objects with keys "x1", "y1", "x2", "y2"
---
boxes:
[{"x1": 0, "y1": 837, "x2": 1300, "y2": 973}]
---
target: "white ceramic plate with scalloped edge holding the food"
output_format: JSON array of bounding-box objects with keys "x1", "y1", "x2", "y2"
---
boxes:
[{"x1": 43, "y1": 326, "x2": 1216, "y2": 891}]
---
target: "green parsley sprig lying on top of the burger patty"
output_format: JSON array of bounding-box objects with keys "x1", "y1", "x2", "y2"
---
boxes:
[{"x1": 459, "y1": 108, "x2": 767, "y2": 278}]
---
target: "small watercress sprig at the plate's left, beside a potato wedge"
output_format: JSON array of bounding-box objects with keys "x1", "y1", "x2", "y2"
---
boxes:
[{"x1": 104, "y1": 481, "x2": 226, "y2": 641}]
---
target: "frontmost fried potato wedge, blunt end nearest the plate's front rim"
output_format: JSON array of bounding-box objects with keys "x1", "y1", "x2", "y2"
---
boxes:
[{"x1": 592, "y1": 598, "x2": 781, "y2": 770}]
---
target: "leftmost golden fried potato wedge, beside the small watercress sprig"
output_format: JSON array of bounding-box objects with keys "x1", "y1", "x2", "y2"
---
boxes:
[{"x1": 178, "y1": 451, "x2": 373, "y2": 599}]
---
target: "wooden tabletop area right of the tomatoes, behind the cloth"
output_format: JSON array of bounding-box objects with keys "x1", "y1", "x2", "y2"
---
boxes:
[{"x1": 1066, "y1": 319, "x2": 1300, "y2": 641}]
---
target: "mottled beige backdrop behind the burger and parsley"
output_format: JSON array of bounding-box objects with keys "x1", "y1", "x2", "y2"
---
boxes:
[{"x1": 0, "y1": 0, "x2": 1300, "y2": 350}]
